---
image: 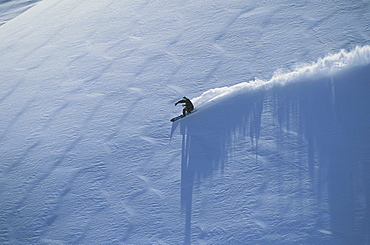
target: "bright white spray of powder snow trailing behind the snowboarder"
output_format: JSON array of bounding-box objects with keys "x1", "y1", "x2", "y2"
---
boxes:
[{"x1": 193, "y1": 45, "x2": 370, "y2": 109}]
